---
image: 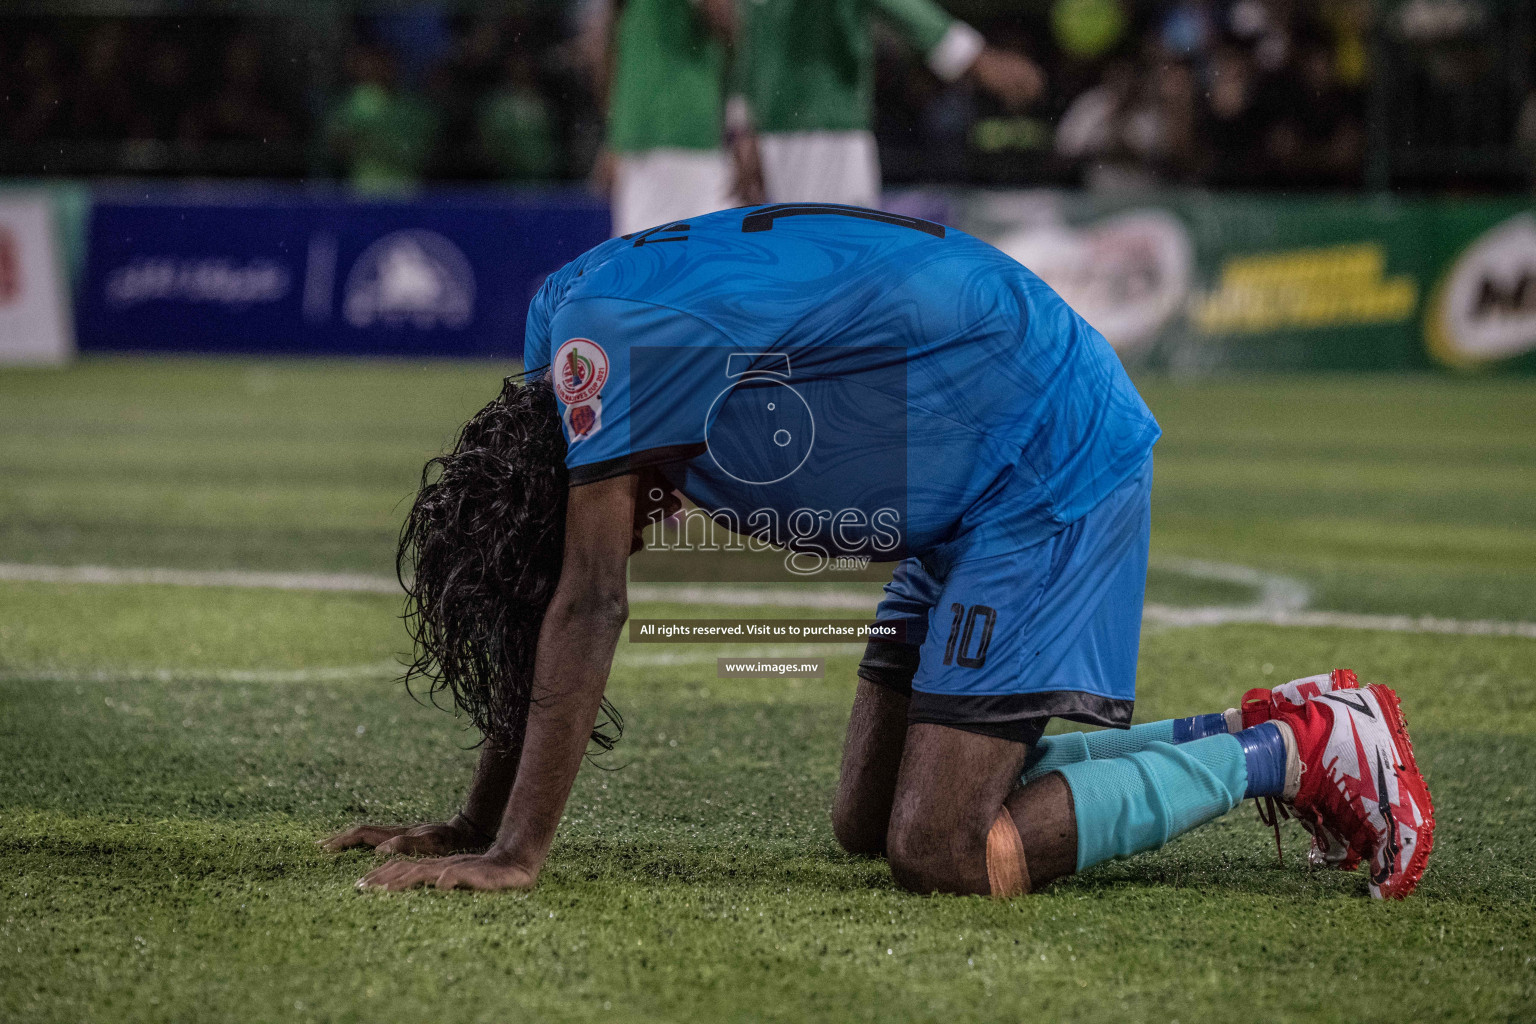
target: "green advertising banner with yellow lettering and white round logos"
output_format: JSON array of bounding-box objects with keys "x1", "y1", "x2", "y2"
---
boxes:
[{"x1": 949, "y1": 192, "x2": 1536, "y2": 372}]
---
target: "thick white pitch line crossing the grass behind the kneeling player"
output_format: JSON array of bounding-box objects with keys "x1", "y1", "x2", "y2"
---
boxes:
[{"x1": 0, "y1": 559, "x2": 1536, "y2": 641}]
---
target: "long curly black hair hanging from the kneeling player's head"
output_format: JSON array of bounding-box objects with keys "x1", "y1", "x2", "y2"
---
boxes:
[{"x1": 395, "y1": 375, "x2": 624, "y2": 752}]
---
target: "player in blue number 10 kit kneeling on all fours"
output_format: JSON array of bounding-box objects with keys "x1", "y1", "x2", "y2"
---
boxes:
[{"x1": 327, "y1": 204, "x2": 1435, "y2": 897}]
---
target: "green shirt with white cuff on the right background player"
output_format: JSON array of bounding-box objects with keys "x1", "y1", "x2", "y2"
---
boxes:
[{"x1": 733, "y1": 0, "x2": 980, "y2": 132}]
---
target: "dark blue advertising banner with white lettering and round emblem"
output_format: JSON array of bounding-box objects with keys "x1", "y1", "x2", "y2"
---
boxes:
[{"x1": 78, "y1": 190, "x2": 608, "y2": 358}]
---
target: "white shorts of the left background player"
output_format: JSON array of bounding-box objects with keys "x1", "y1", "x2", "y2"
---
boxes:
[{"x1": 611, "y1": 149, "x2": 734, "y2": 235}]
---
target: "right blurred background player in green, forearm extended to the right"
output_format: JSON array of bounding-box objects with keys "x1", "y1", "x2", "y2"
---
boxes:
[{"x1": 731, "y1": 0, "x2": 1044, "y2": 207}]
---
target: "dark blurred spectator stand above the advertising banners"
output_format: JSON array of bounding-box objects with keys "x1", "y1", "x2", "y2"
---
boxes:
[{"x1": 0, "y1": 0, "x2": 1536, "y2": 192}]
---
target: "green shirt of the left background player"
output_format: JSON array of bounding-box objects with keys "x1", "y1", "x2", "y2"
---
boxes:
[{"x1": 608, "y1": 0, "x2": 725, "y2": 154}]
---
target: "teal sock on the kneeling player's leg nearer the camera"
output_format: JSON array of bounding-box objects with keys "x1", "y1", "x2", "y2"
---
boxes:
[{"x1": 1054, "y1": 736, "x2": 1247, "y2": 870}]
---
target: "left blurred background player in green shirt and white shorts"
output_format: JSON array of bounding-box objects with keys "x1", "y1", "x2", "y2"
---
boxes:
[{"x1": 585, "y1": 0, "x2": 736, "y2": 235}]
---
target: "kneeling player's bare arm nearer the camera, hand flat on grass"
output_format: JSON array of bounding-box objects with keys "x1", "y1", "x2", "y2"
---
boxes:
[{"x1": 358, "y1": 474, "x2": 637, "y2": 889}]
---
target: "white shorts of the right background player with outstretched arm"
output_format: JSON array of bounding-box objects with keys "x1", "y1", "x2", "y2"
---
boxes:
[{"x1": 759, "y1": 132, "x2": 880, "y2": 207}]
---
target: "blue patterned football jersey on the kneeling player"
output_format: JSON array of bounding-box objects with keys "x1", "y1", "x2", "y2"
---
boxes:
[{"x1": 524, "y1": 204, "x2": 1160, "y2": 560}]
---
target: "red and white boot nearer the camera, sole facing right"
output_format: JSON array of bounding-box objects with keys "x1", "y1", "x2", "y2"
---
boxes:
[{"x1": 1276, "y1": 686, "x2": 1435, "y2": 900}]
